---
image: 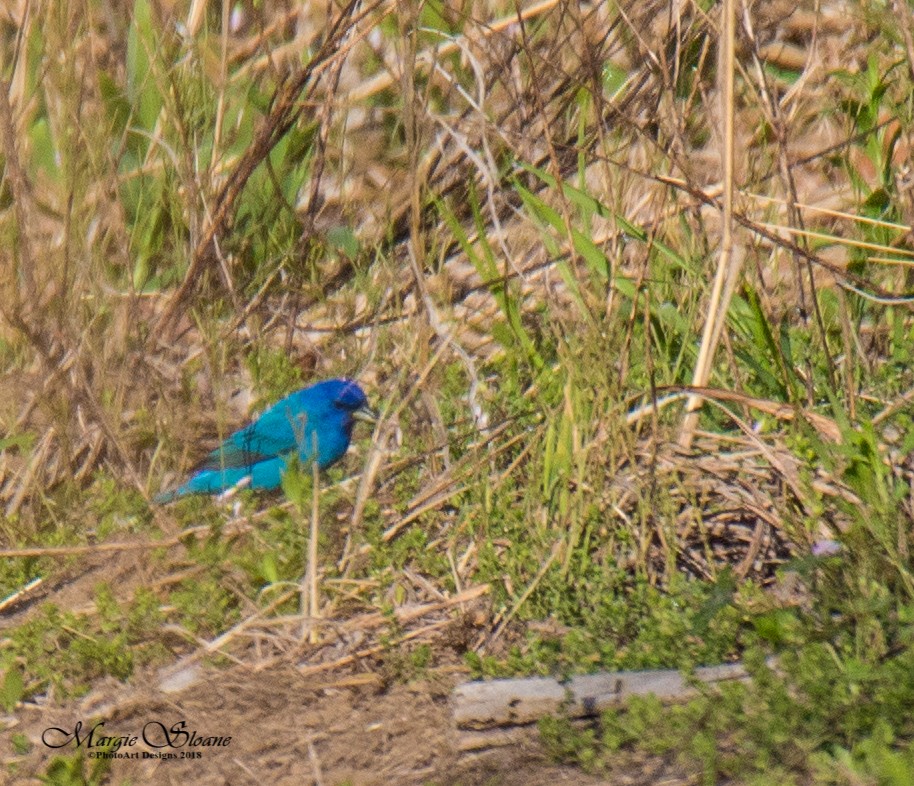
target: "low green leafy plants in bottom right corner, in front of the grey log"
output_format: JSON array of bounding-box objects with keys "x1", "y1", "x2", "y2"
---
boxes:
[{"x1": 540, "y1": 629, "x2": 914, "y2": 786}]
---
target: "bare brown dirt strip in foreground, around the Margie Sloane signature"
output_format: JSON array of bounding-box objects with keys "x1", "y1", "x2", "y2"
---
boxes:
[{"x1": 0, "y1": 666, "x2": 695, "y2": 786}]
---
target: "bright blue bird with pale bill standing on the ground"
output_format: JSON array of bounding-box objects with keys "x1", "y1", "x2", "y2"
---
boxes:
[{"x1": 153, "y1": 379, "x2": 375, "y2": 504}]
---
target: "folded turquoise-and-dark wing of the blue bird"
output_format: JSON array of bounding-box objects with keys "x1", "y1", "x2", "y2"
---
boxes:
[{"x1": 197, "y1": 402, "x2": 307, "y2": 470}]
